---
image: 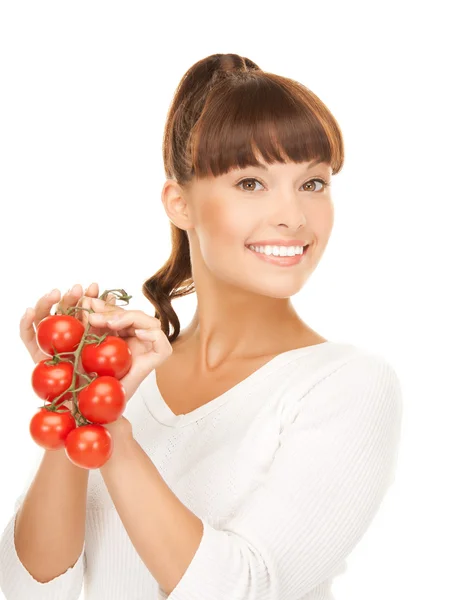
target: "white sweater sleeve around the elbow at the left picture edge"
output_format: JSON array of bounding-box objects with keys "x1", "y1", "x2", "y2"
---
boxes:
[{"x1": 0, "y1": 460, "x2": 86, "y2": 600}]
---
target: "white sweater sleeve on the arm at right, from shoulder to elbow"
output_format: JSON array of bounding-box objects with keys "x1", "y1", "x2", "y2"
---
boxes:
[{"x1": 164, "y1": 354, "x2": 402, "y2": 600}]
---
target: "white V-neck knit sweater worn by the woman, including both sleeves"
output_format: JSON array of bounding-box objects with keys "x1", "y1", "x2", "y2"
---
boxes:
[{"x1": 0, "y1": 342, "x2": 402, "y2": 600}]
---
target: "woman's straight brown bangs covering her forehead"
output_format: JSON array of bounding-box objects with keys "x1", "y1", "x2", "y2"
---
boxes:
[{"x1": 188, "y1": 72, "x2": 344, "y2": 179}]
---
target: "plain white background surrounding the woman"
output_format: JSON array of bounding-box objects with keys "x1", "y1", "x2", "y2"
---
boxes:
[{"x1": 0, "y1": 1, "x2": 466, "y2": 600}]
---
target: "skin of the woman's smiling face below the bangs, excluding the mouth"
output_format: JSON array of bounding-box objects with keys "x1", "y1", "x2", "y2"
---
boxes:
[{"x1": 170, "y1": 162, "x2": 334, "y2": 298}]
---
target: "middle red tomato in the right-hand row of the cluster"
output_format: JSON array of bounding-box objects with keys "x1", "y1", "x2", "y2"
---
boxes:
[{"x1": 78, "y1": 375, "x2": 126, "y2": 425}]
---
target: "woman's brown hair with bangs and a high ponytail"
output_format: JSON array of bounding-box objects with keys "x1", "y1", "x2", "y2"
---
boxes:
[{"x1": 142, "y1": 54, "x2": 344, "y2": 343}]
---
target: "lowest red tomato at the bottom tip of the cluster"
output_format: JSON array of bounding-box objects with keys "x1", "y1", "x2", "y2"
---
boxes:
[{"x1": 65, "y1": 425, "x2": 113, "y2": 469}]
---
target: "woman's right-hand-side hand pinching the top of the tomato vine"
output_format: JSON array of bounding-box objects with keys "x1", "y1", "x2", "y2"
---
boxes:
[{"x1": 88, "y1": 298, "x2": 173, "y2": 401}]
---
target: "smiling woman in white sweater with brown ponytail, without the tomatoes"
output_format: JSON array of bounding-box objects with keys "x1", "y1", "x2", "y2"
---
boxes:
[{"x1": 0, "y1": 54, "x2": 402, "y2": 600}]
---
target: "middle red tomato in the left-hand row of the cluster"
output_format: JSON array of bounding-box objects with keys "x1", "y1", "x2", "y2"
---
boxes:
[{"x1": 31, "y1": 359, "x2": 74, "y2": 406}]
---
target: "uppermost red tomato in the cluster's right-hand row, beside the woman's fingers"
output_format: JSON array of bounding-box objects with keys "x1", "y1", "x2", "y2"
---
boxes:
[{"x1": 81, "y1": 335, "x2": 132, "y2": 379}]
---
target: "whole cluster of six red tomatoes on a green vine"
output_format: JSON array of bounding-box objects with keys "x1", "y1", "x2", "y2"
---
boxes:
[{"x1": 29, "y1": 314, "x2": 131, "y2": 469}]
